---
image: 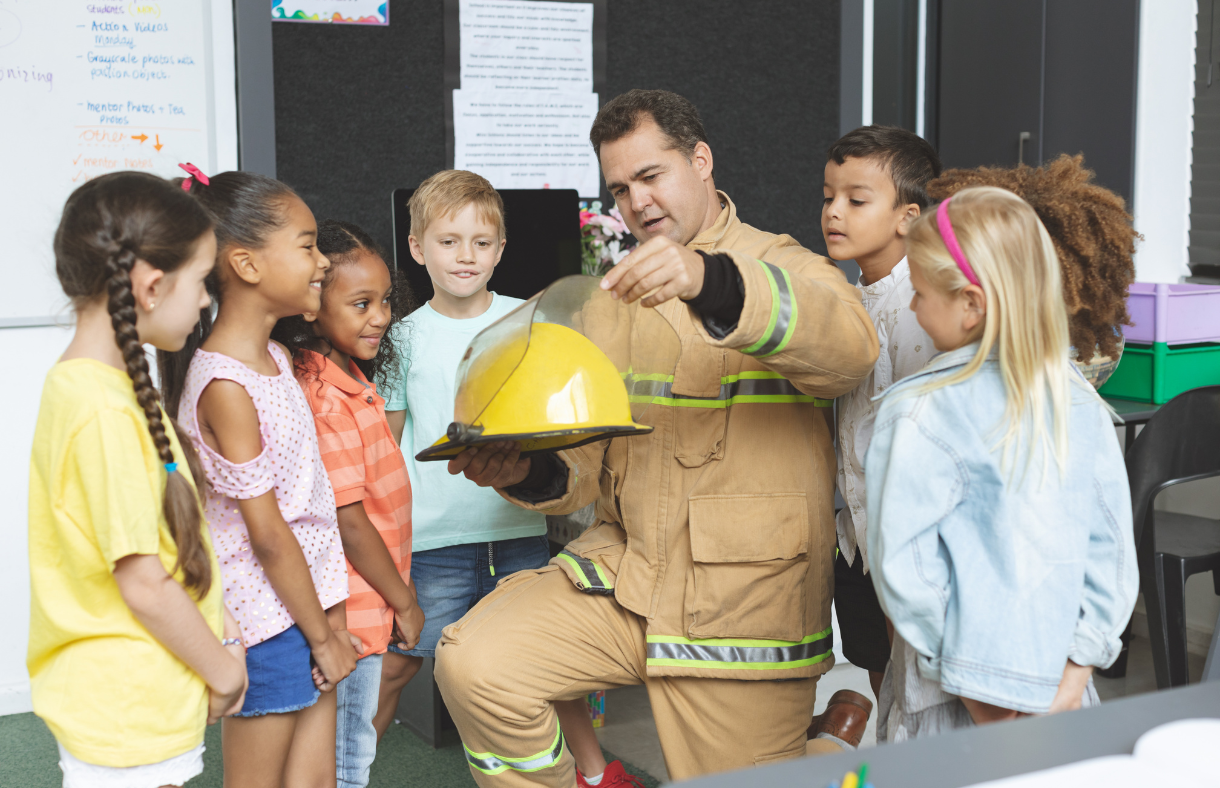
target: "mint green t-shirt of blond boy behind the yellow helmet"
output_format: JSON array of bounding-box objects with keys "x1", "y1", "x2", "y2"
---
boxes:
[{"x1": 386, "y1": 293, "x2": 547, "y2": 551}]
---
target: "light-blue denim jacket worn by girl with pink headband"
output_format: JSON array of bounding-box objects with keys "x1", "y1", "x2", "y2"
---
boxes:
[{"x1": 865, "y1": 344, "x2": 1138, "y2": 712}]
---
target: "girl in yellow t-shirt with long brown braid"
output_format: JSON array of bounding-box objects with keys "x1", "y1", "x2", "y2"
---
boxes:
[{"x1": 27, "y1": 172, "x2": 246, "y2": 787}]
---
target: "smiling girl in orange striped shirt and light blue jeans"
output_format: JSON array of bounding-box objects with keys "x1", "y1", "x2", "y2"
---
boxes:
[{"x1": 272, "y1": 220, "x2": 423, "y2": 788}]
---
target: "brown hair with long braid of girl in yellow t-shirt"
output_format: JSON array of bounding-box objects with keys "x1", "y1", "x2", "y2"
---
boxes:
[{"x1": 55, "y1": 172, "x2": 212, "y2": 598}]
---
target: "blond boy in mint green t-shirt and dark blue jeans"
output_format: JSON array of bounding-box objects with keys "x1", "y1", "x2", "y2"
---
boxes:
[{"x1": 375, "y1": 170, "x2": 630, "y2": 786}]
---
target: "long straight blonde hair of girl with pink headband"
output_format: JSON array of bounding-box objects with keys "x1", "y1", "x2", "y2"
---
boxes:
[{"x1": 906, "y1": 187, "x2": 1096, "y2": 475}]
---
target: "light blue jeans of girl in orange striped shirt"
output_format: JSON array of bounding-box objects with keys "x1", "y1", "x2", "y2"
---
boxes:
[{"x1": 334, "y1": 654, "x2": 382, "y2": 788}]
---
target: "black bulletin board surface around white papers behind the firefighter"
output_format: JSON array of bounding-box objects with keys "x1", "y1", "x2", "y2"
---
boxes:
[{"x1": 272, "y1": 0, "x2": 839, "y2": 272}]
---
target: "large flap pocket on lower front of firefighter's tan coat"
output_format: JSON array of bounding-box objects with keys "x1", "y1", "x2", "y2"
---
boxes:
[{"x1": 686, "y1": 493, "x2": 811, "y2": 642}]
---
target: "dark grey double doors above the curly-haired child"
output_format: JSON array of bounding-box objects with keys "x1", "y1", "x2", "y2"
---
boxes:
[{"x1": 930, "y1": 0, "x2": 1139, "y2": 204}]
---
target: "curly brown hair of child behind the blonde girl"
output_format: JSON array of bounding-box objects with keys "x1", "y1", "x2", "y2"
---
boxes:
[{"x1": 927, "y1": 154, "x2": 1141, "y2": 388}]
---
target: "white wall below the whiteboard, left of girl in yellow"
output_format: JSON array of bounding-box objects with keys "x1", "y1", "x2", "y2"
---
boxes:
[{"x1": 0, "y1": 328, "x2": 71, "y2": 715}]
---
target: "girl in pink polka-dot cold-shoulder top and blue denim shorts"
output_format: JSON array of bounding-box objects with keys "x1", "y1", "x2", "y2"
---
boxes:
[{"x1": 160, "y1": 167, "x2": 362, "y2": 788}]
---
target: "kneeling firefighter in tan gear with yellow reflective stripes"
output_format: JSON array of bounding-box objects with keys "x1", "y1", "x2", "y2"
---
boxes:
[{"x1": 436, "y1": 90, "x2": 877, "y2": 788}]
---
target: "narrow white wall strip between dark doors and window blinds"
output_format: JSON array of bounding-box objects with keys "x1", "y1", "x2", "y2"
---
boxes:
[{"x1": 1132, "y1": 0, "x2": 1197, "y2": 282}]
